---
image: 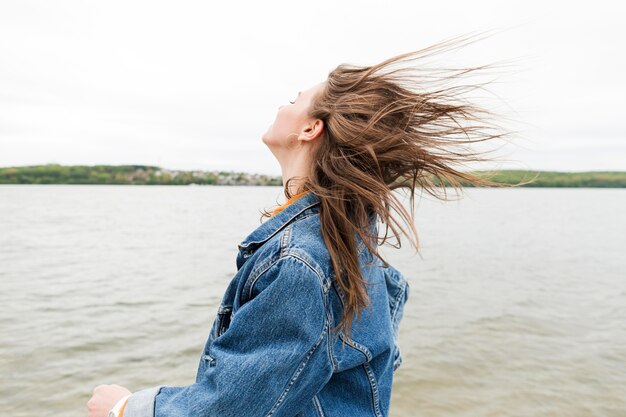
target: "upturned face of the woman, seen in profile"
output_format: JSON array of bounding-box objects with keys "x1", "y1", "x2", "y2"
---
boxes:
[{"x1": 263, "y1": 82, "x2": 325, "y2": 154}]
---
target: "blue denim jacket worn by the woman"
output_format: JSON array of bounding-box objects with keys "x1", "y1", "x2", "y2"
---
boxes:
[{"x1": 124, "y1": 192, "x2": 409, "y2": 417}]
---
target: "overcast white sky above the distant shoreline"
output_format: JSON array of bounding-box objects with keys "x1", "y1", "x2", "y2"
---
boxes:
[{"x1": 0, "y1": 0, "x2": 626, "y2": 175}]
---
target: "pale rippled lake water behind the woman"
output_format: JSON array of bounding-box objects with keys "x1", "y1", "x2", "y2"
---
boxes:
[{"x1": 0, "y1": 185, "x2": 626, "y2": 417}]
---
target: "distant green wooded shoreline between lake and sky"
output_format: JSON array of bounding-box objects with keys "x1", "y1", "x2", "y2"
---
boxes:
[{"x1": 0, "y1": 164, "x2": 626, "y2": 188}]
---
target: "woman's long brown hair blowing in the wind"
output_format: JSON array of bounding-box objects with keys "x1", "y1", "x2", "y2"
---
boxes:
[{"x1": 266, "y1": 34, "x2": 520, "y2": 339}]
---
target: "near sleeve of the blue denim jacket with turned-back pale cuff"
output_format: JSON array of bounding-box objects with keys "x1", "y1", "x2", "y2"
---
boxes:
[{"x1": 124, "y1": 255, "x2": 333, "y2": 417}]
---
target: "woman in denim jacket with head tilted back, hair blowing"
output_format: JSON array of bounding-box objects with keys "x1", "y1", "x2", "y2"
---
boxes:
[{"x1": 88, "y1": 34, "x2": 508, "y2": 417}]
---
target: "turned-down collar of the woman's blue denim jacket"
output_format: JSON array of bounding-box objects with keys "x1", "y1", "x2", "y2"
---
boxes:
[{"x1": 237, "y1": 191, "x2": 320, "y2": 254}]
